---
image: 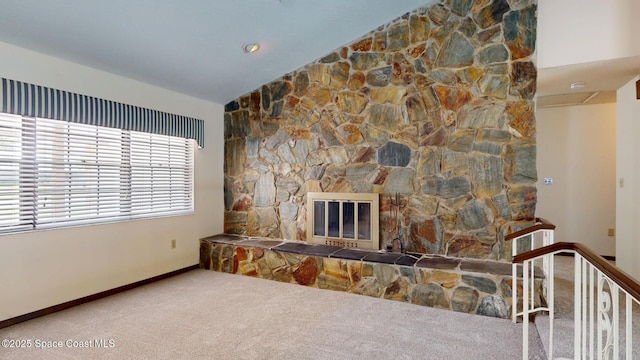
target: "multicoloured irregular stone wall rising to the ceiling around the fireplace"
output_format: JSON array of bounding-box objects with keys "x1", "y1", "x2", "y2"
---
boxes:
[{"x1": 224, "y1": 0, "x2": 537, "y2": 260}]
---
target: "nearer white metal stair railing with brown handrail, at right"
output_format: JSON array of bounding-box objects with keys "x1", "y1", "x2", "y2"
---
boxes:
[{"x1": 513, "y1": 242, "x2": 640, "y2": 359}]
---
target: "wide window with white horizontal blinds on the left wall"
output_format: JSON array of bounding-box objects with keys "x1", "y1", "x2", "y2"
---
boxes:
[{"x1": 0, "y1": 114, "x2": 194, "y2": 232}]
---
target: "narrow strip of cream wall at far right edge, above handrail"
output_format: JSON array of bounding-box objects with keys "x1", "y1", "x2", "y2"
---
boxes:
[{"x1": 616, "y1": 77, "x2": 640, "y2": 279}]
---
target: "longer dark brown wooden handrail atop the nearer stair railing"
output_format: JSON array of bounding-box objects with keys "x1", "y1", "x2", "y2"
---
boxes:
[{"x1": 512, "y1": 242, "x2": 640, "y2": 302}]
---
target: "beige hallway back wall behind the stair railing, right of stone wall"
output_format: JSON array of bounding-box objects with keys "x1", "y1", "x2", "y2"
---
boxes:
[{"x1": 536, "y1": 104, "x2": 616, "y2": 256}]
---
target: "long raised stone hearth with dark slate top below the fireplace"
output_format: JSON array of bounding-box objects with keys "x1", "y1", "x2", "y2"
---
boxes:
[{"x1": 200, "y1": 235, "x2": 542, "y2": 319}]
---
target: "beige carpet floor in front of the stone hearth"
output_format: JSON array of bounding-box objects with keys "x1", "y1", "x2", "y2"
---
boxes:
[{"x1": 0, "y1": 270, "x2": 542, "y2": 359}]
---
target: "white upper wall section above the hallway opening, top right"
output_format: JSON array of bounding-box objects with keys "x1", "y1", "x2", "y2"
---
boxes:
[{"x1": 537, "y1": 0, "x2": 640, "y2": 69}]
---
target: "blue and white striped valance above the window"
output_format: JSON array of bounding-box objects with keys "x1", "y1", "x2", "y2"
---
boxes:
[{"x1": 0, "y1": 78, "x2": 204, "y2": 147}]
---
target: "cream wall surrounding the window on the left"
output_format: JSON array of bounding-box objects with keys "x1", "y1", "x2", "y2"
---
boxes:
[{"x1": 0, "y1": 43, "x2": 224, "y2": 320}]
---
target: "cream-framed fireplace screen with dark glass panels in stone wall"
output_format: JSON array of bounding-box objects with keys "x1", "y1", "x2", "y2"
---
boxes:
[{"x1": 307, "y1": 193, "x2": 379, "y2": 250}]
